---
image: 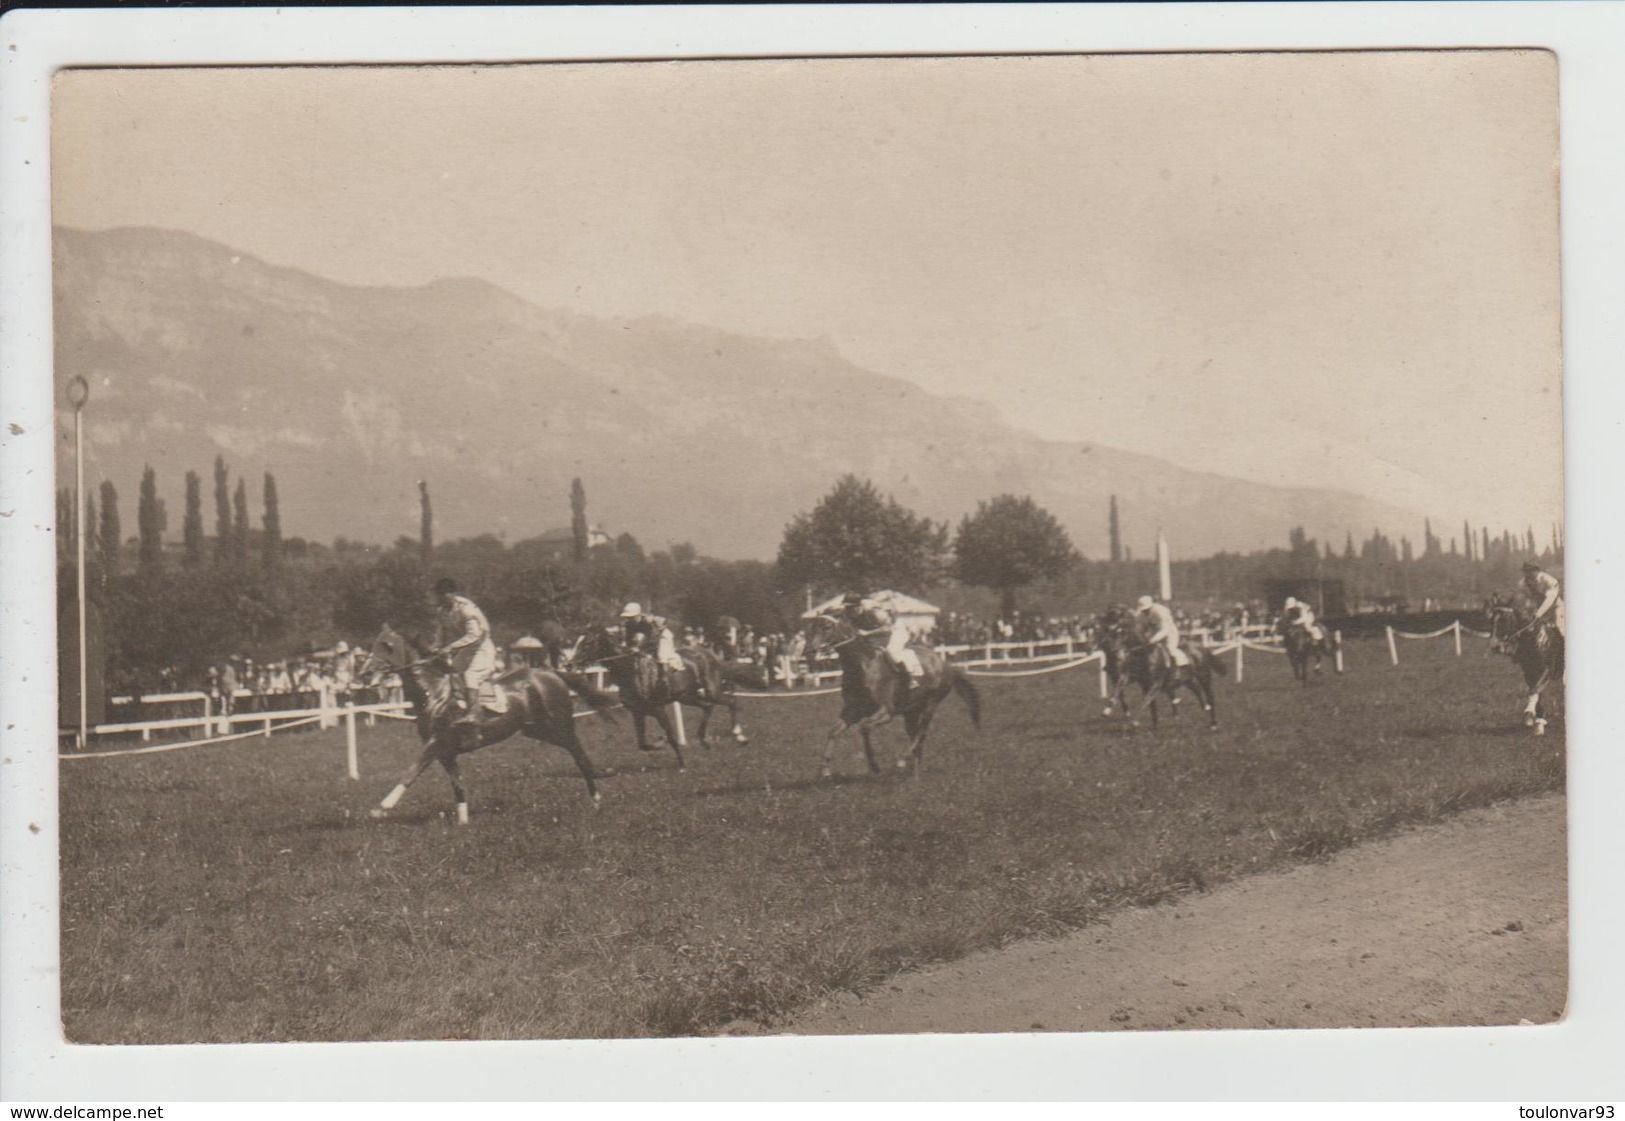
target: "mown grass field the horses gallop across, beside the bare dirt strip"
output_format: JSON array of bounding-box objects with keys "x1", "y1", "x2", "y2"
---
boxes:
[{"x1": 60, "y1": 643, "x2": 1563, "y2": 1043}]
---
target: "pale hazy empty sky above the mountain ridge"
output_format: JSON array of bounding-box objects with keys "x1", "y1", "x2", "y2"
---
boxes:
[{"x1": 54, "y1": 52, "x2": 1562, "y2": 538}]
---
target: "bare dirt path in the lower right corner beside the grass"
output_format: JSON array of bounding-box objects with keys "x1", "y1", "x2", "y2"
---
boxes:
[{"x1": 778, "y1": 796, "x2": 1568, "y2": 1035}]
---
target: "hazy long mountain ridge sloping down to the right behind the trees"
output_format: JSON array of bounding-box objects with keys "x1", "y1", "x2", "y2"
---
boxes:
[{"x1": 55, "y1": 229, "x2": 1422, "y2": 557}]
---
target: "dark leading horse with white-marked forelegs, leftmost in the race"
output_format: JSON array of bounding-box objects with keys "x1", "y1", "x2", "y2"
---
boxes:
[{"x1": 358, "y1": 625, "x2": 614, "y2": 825}]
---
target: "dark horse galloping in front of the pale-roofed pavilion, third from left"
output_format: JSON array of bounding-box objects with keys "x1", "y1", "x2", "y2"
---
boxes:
[{"x1": 806, "y1": 616, "x2": 982, "y2": 778}]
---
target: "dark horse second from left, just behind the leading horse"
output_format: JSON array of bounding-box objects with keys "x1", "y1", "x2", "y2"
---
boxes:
[{"x1": 570, "y1": 625, "x2": 749, "y2": 770}]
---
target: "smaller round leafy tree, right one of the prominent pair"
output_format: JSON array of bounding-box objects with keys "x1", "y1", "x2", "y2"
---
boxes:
[{"x1": 954, "y1": 494, "x2": 1079, "y2": 617}]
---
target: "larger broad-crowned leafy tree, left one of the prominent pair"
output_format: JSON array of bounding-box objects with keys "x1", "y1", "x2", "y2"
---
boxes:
[{"x1": 778, "y1": 474, "x2": 947, "y2": 591}]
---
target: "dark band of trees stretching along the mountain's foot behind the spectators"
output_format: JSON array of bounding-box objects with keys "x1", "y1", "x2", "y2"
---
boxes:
[{"x1": 57, "y1": 457, "x2": 1562, "y2": 692}]
